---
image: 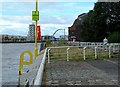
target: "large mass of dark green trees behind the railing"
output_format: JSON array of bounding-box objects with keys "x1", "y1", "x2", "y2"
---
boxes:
[{"x1": 77, "y1": 2, "x2": 120, "y2": 42}]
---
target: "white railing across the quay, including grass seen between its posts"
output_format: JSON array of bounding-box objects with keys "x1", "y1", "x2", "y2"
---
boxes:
[{"x1": 48, "y1": 45, "x2": 120, "y2": 63}]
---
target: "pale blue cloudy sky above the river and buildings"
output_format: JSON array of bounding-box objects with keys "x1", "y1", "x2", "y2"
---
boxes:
[{"x1": 0, "y1": 0, "x2": 96, "y2": 37}]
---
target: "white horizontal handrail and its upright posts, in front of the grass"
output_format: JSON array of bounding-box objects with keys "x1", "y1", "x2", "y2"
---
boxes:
[{"x1": 48, "y1": 45, "x2": 120, "y2": 63}]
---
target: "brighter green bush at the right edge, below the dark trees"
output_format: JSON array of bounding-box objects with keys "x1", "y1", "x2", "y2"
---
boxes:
[{"x1": 108, "y1": 32, "x2": 120, "y2": 43}]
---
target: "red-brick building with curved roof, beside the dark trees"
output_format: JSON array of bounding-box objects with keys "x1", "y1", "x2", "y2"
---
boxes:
[{"x1": 68, "y1": 13, "x2": 87, "y2": 41}]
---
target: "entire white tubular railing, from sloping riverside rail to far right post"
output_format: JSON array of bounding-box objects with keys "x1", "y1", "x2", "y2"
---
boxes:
[{"x1": 18, "y1": 45, "x2": 119, "y2": 86}]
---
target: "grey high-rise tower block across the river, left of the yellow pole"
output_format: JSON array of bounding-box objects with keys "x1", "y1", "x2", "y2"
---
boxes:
[{"x1": 27, "y1": 24, "x2": 35, "y2": 41}]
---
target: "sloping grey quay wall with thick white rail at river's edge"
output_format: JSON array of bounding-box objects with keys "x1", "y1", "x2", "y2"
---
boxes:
[{"x1": 18, "y1": 50, "x2": 46, "y2": 87}]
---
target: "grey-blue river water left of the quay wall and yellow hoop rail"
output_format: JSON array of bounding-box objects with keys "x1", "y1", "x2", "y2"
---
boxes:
[{"x1": 0, "y1": 43, "x2": 40, "y2": 85}]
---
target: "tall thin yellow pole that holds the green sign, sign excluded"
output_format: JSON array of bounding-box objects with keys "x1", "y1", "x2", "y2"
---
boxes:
[{"x1": 34, "y1": 0, "x2": 38, "y2": 59}]
